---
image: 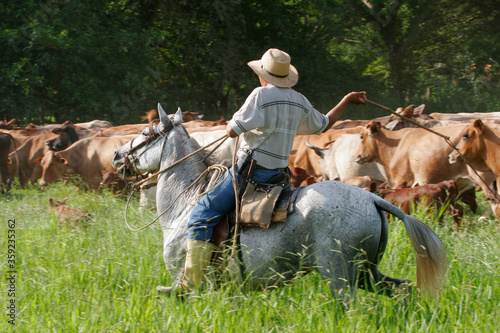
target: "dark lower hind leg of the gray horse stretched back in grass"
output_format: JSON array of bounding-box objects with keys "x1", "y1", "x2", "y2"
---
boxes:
[{"x1": 358, "y1": 265, "x2": 411, "y2": 297}]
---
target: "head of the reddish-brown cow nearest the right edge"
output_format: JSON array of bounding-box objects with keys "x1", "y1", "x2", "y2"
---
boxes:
[{"x1": 448, "y1": 119, "x2": 488, "y2": 171}]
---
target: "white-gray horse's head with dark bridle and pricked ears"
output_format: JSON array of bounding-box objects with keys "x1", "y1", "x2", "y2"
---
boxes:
[{"x1": 113, "y1": 103, "x2": 187, "y2": 175}]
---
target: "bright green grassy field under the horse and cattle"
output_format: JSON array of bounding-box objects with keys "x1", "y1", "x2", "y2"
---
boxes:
[{"x1": 0, "y1": 184, "x2": 500, "y2": 333}]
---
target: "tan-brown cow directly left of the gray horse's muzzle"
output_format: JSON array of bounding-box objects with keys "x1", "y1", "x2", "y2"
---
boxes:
[{"x1": 40, "y1": 135, "x2": 137, "y2": 189}]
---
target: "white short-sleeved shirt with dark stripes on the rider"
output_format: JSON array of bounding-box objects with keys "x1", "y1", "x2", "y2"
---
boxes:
[{"x1": 229, "y1": 84, "x2": 329, "y2": 169}]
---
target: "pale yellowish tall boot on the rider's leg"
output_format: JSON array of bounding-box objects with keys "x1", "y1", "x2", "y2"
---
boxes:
[{"x1": 156, "y1": 239, "x2": 215, "y2": 295}]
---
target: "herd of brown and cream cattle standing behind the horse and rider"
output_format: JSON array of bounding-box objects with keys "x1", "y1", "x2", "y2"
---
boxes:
[{"x1": 0, "y1": 105, "x2": 500, "y2": 230}]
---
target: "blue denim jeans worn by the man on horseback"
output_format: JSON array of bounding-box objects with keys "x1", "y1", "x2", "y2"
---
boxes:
[{"x1": 188, "y1": 169, "x2": 279, "y2": 242}]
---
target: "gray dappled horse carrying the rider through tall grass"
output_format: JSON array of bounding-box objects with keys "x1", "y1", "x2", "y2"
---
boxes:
[{"x1": 113, "y1": 105, "x2": 447, "y2": 301}]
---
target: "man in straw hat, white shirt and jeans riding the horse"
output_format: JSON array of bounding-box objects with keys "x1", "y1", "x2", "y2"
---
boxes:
[{"x1": 157, "y1": 49, "x2": 366, "y2": 293}]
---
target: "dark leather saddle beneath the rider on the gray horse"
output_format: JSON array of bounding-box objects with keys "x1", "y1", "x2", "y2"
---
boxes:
[{"x1": 211, "y1": 186, "x2": 305, "y2": 250}]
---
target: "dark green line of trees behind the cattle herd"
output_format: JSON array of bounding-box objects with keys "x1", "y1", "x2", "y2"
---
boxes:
[{"x1": 0, "y1": 0, "x2": 500, "y2": 124}]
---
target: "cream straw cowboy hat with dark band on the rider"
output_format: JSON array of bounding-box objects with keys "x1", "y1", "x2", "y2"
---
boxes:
[{"x1": 248, "y1": 49, "x2": 299, "y2": 88}]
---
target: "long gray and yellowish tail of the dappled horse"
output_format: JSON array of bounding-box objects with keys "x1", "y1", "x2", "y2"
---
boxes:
[{"x1": 374, "y1": 195, "x2": 448, "y2": 295}]
